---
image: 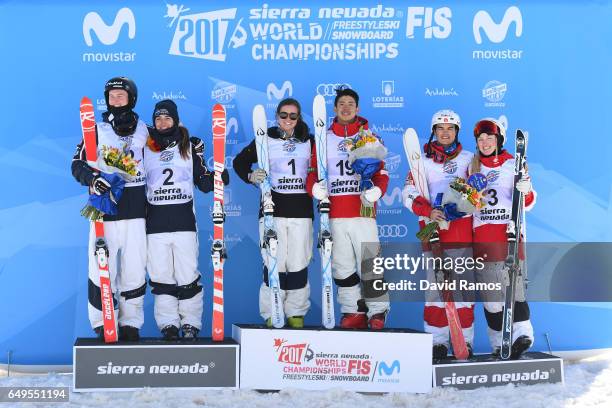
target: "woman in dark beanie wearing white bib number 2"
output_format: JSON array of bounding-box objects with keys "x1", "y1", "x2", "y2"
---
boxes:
[{"x1": 144, "y1": 99, "x2": 229, "y2": 340}]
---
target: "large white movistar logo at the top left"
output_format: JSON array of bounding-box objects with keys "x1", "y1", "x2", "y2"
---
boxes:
[{"x1": 82, "y1": 7, "x2": 136, "y2": 62}]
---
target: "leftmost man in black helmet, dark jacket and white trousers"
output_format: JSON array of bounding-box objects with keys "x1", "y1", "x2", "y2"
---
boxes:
[{"x1": 71, "y1": 77, "x2": 148, "y2": 341}]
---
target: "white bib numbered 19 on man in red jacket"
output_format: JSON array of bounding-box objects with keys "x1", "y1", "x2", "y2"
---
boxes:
[{"x1": 327, "y1": 131, "x2": 360, "y2": 196}]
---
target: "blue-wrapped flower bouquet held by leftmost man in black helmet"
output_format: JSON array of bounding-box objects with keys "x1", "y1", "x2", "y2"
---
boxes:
[{"x1": 81, "y1": 144, "x2": 139, "y2": 221}]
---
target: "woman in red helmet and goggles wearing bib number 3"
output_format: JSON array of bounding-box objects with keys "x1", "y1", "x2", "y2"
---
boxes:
[{"x1": 470, "y1": 118, "x2": 536, "y2": 359}]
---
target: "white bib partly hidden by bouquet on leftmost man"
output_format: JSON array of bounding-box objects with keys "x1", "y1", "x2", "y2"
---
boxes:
[{"x1": 97, "y1": 120, "x2": 149, "y2": 187}]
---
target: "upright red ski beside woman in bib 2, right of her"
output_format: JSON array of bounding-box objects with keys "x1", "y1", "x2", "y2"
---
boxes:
[{"x1": 211, "y1": 103, "x2": 227, "y2": 341}]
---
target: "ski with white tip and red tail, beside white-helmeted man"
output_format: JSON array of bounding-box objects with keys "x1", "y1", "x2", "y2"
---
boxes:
[{"x1": 403, "y1": 128, "x2": 469, "y2": 360}]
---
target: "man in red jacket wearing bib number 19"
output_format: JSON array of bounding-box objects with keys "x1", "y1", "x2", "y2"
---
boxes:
[{"x1": 307, "y1": 87, "x2": 389, "y2": 330}]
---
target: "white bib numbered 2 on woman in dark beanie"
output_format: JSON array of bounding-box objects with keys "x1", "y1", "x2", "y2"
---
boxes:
[{"x1": 144, "y1": 146, "x2": 193, "y2": 205}]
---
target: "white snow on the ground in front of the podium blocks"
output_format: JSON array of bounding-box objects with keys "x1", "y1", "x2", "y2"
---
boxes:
[{"x1": 0, "y1": 353, "x2": 612, "y2": 408}]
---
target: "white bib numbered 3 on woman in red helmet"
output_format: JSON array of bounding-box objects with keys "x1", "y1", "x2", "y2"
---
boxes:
[{"x1": 474, "y1": 159, "x2": 514, "y2": 227}]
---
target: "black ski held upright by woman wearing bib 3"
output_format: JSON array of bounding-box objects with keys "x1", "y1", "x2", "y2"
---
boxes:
[{"x1": 500, "y1": 129, "x2": 527, "y2": 360}]
